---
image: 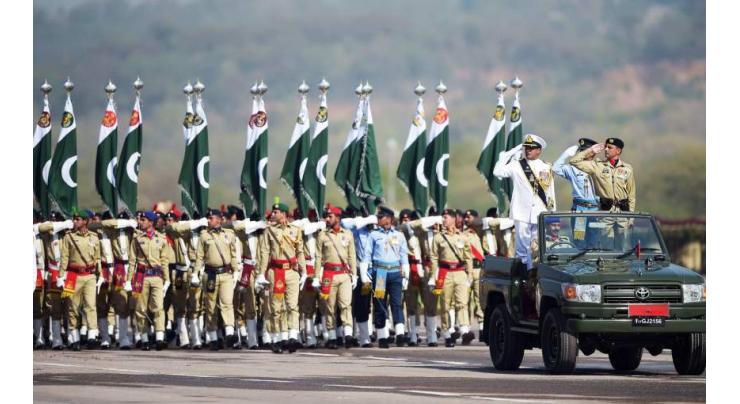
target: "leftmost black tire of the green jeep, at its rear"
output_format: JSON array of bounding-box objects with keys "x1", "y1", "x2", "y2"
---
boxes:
[{"x1": 488, "y1": 303, "x2": 524, "y2": 370}]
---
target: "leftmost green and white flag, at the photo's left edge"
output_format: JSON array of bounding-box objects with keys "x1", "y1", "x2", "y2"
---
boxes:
[{"x1": 33, "y1": 94, "x2": 51, "y2": 217}]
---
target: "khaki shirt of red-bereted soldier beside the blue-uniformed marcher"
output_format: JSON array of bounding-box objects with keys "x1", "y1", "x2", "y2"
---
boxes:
[{"x1": 315, "y1": 229, "x2": 357, "y2": 279}]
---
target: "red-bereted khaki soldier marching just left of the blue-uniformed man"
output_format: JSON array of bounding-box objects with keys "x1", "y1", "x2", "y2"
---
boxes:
[{"x1": 314, "y1": 204, "x2": 357, "y2": 349}]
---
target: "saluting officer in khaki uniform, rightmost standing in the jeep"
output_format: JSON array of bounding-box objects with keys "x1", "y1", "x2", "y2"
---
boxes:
[{"x1": 570, "y1": 137, "x2": 637, "y2": 212}]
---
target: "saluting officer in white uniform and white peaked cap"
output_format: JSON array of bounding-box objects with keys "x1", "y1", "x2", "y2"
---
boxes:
[{"x1": 493, "y1": 134, "x2": 555, "y2": 269}]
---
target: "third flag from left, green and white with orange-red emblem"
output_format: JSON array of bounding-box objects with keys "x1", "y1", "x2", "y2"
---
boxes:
[{"x1": 95, "y1": 97, "x2": 118, "y2": 216}]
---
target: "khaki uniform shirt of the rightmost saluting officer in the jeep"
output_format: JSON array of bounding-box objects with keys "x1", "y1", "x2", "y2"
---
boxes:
[{"x1": 570, "y1": 149, "x2": 637, "y2": 212}]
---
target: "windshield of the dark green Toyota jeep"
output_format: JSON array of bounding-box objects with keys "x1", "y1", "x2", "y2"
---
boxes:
[{"x1": 544, "y1": 214, "x2": 664, "y2": 256}]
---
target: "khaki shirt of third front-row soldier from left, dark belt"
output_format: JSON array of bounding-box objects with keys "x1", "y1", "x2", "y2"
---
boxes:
[{"x1": 194, "y1": 227, "x2": 240, "y2": 274}]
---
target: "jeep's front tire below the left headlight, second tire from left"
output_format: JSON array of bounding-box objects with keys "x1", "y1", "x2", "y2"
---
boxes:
[{"x1": 540, "y1": 307, "x2": 578, "y2": 373}]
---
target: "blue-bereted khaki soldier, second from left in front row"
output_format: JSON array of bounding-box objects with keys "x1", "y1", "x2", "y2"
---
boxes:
[{"x1": 125, "y1": 211, "x2": 171, "y2": 351}]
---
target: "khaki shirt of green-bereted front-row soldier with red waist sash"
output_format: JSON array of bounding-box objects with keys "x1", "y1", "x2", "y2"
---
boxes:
[{"x1": 258, "y1": 224, "x2": 306, "y2": 274}]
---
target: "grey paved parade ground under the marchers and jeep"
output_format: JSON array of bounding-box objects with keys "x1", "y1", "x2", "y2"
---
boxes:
[{"x1": 33, "y1": 341, "x2": 706, "y2": 404}]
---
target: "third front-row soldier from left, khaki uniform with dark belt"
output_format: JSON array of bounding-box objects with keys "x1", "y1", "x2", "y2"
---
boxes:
[{"x1": 193, "y1": 209, "x2": 241, "y2": 351}]
